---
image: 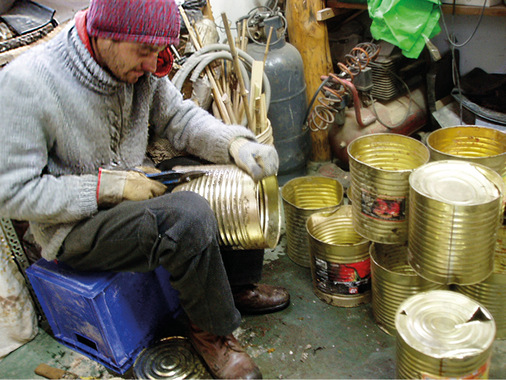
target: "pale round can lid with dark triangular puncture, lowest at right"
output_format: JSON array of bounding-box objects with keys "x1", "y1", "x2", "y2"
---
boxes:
[{"x1": 395, "y1": 290, "x2": 496, "y2": 359}]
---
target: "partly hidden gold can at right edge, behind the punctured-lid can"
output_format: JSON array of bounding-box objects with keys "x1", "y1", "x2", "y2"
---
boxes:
[{"x1": 456, "y1": 226, "x2": 506, "y2": 339}]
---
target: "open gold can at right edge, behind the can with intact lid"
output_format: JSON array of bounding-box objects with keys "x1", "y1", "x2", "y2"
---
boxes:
[{"x1": 427, "y1": 125, "x2": 506, "y2": 177}]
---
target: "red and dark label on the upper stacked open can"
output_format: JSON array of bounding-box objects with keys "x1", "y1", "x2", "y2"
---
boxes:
[{"x1": 361, "y1": 189, "x2": 406, "y2": 222}]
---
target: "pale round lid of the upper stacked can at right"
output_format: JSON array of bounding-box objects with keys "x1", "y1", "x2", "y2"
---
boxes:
[{"x1": 409, "y1": 160, "x2": 504, "y2": 206}]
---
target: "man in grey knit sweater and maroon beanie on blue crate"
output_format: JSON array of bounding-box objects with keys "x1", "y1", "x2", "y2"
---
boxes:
[{"x1": 0, "y1": 0, "x2": 289, "y2": 378}]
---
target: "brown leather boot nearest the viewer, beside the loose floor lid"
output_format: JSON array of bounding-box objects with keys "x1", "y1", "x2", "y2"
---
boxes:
[{"x1": 190, "y1": 324, "x2": 262, "y2": 379}]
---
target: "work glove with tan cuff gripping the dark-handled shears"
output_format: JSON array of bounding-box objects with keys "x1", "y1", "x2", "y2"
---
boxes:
[{"x1": 97, "y1": 168, "x2": 167, "y2": 207}]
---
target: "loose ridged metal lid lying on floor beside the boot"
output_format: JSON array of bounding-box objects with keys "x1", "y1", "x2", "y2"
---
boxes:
[{"x1": 133, "y1": 336, "x2": 212, "y2": 379}]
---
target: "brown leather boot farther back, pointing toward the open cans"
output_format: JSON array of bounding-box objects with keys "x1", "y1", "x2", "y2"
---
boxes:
[{"x1": 232, "y1": 284, "x2": 290, "y2": 314}]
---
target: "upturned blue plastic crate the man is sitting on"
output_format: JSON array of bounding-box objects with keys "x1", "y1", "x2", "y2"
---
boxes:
[{"x1": 26, "y1": 259, "x2": 181, "y2": 374}]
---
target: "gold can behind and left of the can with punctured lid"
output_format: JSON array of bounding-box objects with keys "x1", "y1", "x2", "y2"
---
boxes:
[{"x1": 369, "y1": 243, "x2": 448, "y2": 335}]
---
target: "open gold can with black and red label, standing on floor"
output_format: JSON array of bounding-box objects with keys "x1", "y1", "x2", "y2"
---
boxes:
[{"x1": 306, "y1": 205, "x2": 371, "y2": 307}]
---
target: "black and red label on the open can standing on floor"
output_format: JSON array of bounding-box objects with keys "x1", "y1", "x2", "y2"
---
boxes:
[{"x1": 315, "y1": 258, "x2": 371, "y2": 295}]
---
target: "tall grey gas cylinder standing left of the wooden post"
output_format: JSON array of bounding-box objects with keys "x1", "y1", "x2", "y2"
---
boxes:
[{"x1": 246, "y1": 15, "x2": 311, "y2": 185}]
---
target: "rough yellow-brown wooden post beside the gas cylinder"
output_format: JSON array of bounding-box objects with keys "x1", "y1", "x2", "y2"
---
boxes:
[{"x1": 286, "y1": 0, "x2": 333, "y2": 162}]
